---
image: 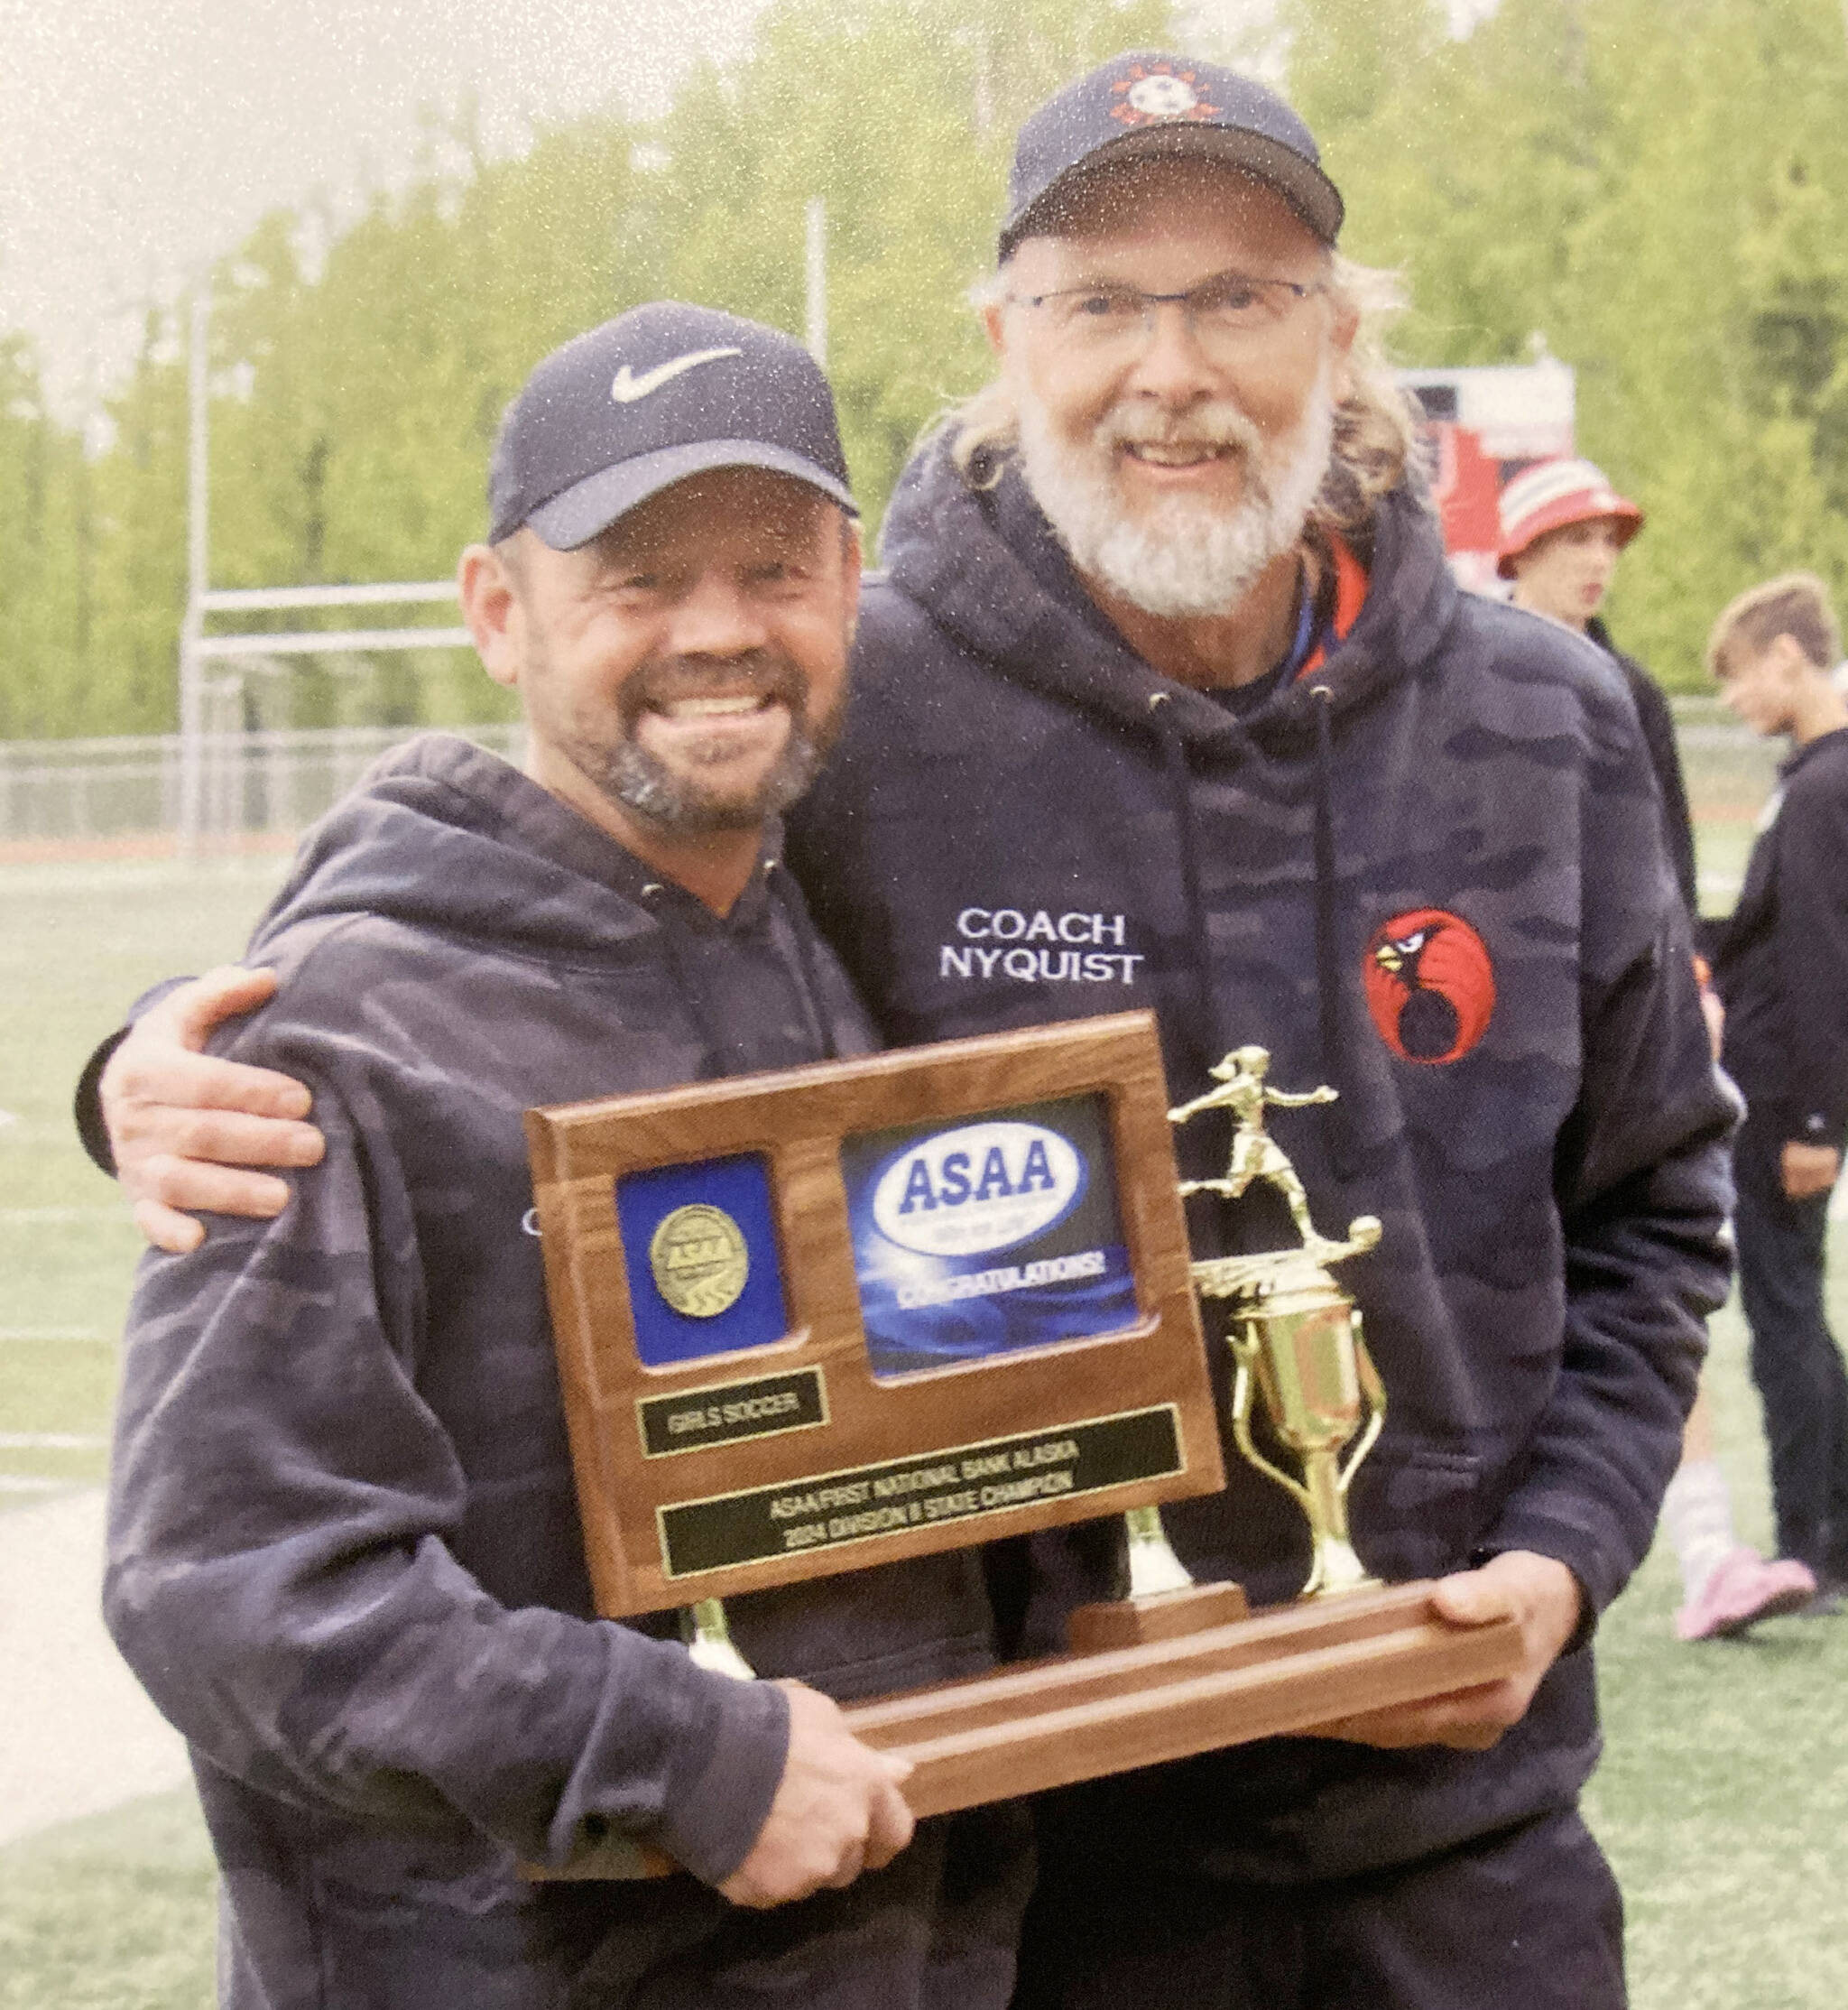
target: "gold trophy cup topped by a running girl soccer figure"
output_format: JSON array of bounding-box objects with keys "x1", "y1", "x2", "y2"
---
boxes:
[{"x1": 1169, "y1": 1047, "x2": 1386, "y2": 1598}]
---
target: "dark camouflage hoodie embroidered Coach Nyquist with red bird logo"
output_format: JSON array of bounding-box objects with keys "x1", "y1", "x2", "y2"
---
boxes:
[{"x1": 790, "y1": 438, "x2": 1732, "y2": 1877}]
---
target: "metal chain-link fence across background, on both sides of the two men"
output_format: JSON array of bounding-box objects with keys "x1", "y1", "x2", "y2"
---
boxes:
[{"x1": 0, "y1": 699, "x2": 1779, "y2": 848}]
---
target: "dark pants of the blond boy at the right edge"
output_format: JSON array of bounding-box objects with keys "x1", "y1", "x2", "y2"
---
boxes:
[{"x1": 1733, "y1": 1117, "x2": 1848, "y2": 1578}]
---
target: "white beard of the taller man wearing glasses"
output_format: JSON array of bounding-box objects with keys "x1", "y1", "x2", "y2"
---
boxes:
[{"x1": 1019, "y1": 357, "x2": 1334, "y2": 617}]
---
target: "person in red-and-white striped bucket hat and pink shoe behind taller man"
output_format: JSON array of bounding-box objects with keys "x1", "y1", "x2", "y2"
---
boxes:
[{"x1": 1496, "y1": 460, "x2": 1816, "y2": 1640}]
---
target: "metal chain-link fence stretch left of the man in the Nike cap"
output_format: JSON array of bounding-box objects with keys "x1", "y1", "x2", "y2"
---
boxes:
[{"x1": 0, "y1": 724, "x2": 526, "y2": 850}]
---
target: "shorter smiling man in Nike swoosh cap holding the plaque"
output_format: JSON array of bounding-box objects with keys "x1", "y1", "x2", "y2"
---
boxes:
[{"x1": 94, "y1": 306, "x2": 1024, "y2": 2010}]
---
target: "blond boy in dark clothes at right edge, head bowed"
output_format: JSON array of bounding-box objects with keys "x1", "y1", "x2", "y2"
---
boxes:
[{"x1": 1707, "y1": 573, "x2": 1848, "y2": 1610}]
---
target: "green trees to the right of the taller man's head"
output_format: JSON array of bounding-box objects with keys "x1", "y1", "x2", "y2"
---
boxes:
[{"x1": 1286, "y1": 0, "x2": 1848, "y2": 690}]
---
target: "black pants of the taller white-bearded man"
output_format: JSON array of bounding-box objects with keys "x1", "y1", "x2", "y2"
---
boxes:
[{"x1": 1014, "y1": 1811, "x2": 1625, "y2": 2010}]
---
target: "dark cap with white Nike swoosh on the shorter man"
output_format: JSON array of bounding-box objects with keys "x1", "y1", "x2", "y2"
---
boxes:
[{"x1": 488, "y1": 300, "x2": 858, "y2": 551}]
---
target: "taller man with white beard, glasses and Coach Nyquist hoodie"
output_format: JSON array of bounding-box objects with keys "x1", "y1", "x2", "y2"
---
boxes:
[{"x1": 86, "y1": 56, "x2": 1730, "y2": 2010}]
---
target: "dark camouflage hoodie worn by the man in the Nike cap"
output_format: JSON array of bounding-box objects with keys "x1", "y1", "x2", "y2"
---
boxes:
[{"x1": 105, "y1": 736, "x2": 1019, "y2": 2010}]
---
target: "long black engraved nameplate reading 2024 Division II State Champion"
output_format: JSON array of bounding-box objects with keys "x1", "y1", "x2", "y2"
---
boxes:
[{"x1": 655, "y1": 1403, "x2": 1187, "y2": 1578}]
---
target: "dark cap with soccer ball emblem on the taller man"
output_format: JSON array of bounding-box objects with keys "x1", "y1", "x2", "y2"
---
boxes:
[{"x1": 1001, "y1": 52, "x2": 1344, "y2": 262}]
